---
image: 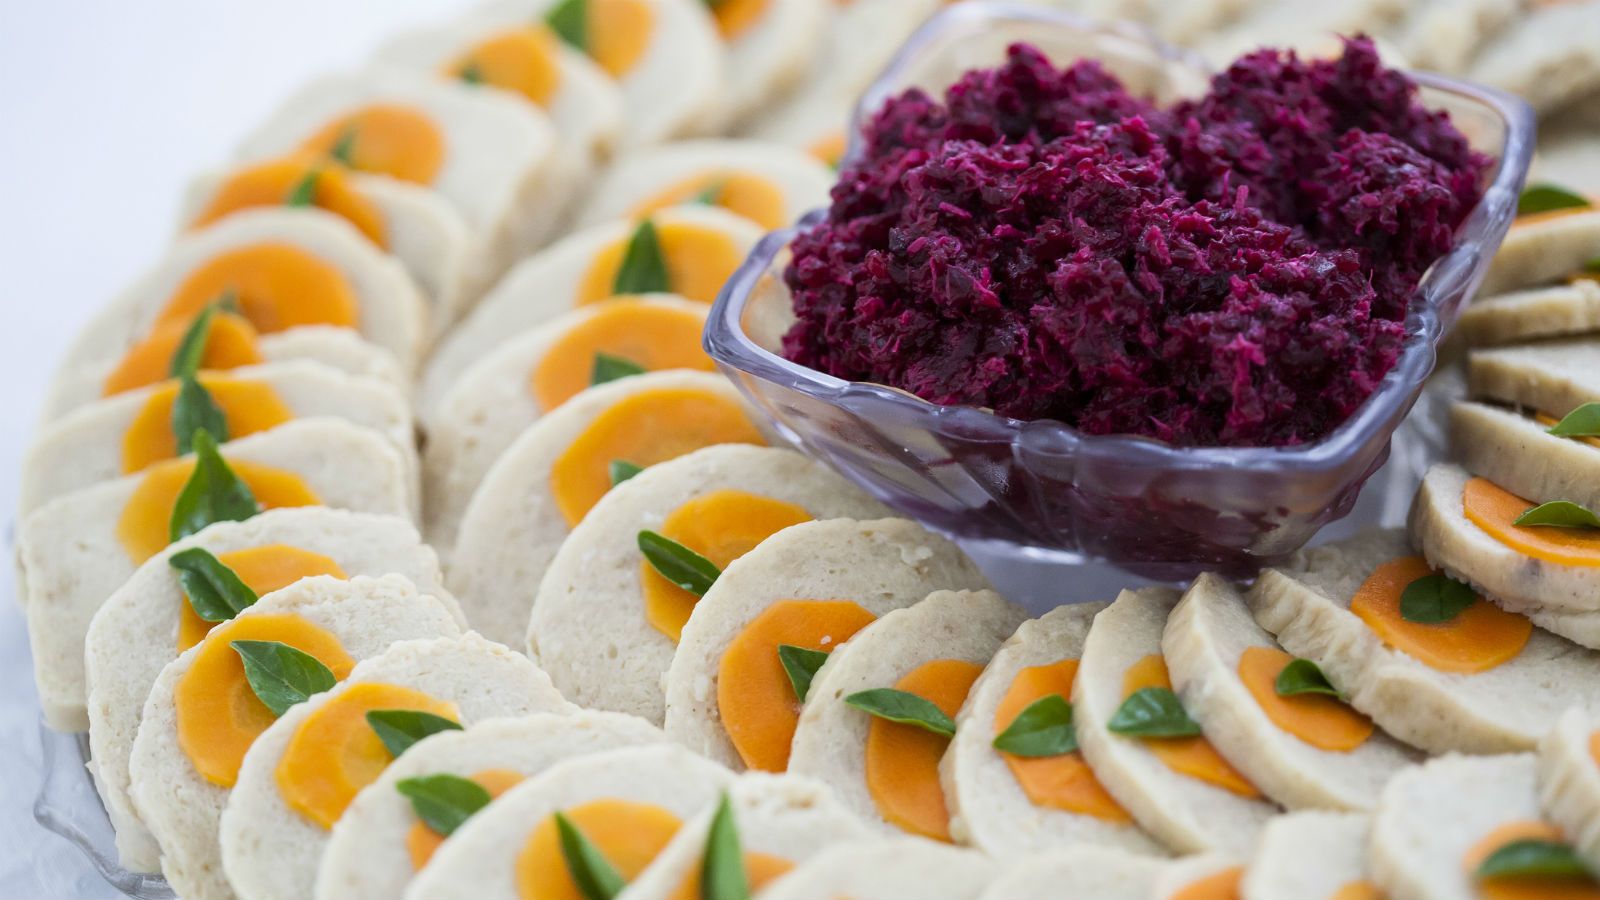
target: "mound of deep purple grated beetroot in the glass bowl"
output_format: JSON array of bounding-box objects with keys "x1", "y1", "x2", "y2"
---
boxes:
[{"x1": 784, "y1": 38, "x2": 1490, "y2": 447}]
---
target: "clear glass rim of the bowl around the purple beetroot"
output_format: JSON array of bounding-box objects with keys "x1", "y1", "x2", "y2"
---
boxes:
[{"x1": 704, "y1": 2, "x2": 1534, "y2": 474}]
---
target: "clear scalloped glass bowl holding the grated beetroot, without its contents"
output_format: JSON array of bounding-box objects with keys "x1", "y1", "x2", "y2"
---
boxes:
[{"x1": 706, "y1": 3, "x2": 1534, "y2": 580}]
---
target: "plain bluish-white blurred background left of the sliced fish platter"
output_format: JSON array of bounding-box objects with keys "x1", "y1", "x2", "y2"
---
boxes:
[{"x1": 0, "y1": 0, "x2": 464, "y2": 900}]
